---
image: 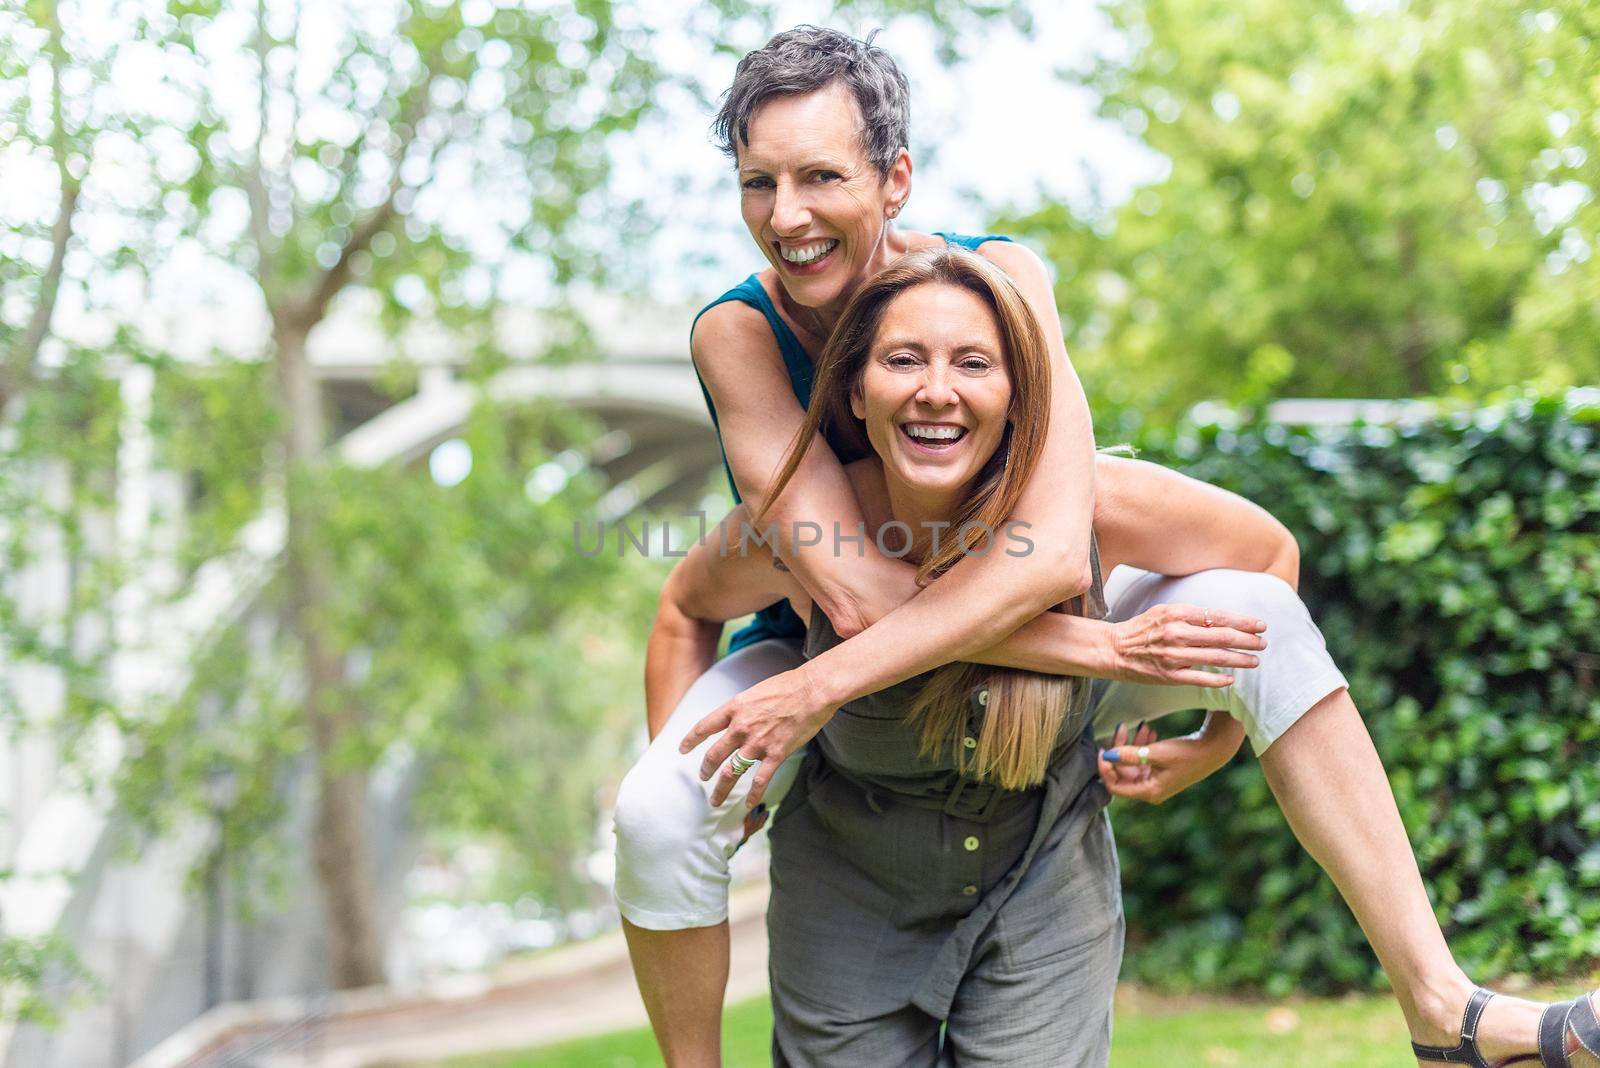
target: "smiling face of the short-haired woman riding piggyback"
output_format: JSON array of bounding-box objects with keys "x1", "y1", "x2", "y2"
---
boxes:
[{"x1": 738, "y1": 82, "x2": 910, "y2": 309}]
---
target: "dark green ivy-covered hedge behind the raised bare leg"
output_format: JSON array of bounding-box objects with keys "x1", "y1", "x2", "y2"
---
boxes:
[{"x1": 1115, "y1": 395, "x2": 1600, "y2": 994}]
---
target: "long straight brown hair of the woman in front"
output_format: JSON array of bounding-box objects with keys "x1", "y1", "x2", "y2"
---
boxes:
[{"x1": 757, "y1": 248, "x2": 1082, "y2": 790}]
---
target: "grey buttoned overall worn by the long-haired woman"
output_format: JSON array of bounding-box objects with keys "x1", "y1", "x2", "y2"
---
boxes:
[{"x1": 766, "y1": 546, "x2": 1123, "y2": 1068}]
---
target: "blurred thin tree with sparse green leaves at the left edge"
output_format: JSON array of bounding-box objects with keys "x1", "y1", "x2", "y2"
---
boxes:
[{"x1": 0, "y1": 0, "x2": 142, "y2": 1028}]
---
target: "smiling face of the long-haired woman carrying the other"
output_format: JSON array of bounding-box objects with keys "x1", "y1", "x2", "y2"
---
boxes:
[{"x1": 850, "y1": 281, "x2": 1011, "y2": 518}]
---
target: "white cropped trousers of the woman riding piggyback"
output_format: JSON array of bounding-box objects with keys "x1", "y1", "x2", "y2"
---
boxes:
[{"x1": 616, "y1": 568, "x2": 1346, "y2": 931}]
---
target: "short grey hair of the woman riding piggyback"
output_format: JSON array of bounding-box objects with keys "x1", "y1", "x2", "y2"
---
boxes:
[{"x1": 710, "y1": 26, "x2": 910, "y2": 174}]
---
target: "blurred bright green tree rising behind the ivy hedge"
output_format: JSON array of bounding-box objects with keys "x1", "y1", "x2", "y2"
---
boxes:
[{"x1": 1002, "y1": 0, "x2": 1600, "y2": 412}]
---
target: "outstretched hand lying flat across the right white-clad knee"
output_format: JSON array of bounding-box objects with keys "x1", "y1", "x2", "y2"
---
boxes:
[{"x1": 1106, "y1": 604, "x2": 1267, "y2": 689}]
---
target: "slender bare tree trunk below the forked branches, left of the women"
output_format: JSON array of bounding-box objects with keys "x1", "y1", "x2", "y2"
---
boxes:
[{"x1": 274, "y1": 315, "x2": 384, "y2": 990}]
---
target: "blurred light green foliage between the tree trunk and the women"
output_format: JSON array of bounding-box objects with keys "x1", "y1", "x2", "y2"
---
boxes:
[{"x1": 308, "y1": 403, "x2": 661, "y2": 907}]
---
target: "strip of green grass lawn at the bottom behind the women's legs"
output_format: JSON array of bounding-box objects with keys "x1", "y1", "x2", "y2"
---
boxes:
[{"x1": 453, "y1": 991, "x2": 1416, "y2": 1068}]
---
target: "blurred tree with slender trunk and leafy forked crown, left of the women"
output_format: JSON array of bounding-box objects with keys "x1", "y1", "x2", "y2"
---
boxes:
[{"x1": 141, "y1": 0, "x2": 658, "y2": 986}]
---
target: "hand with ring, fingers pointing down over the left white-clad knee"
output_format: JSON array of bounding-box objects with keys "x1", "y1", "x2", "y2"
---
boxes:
[{"x1": 678, "y1": 665, "x2": 837, "y2": 809}]
